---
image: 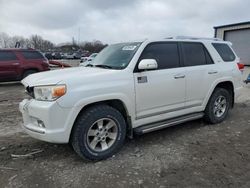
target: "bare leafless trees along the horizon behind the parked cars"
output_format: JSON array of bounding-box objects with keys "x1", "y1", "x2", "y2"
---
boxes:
[{"x1": 0, "y1": 32, "x2": 107, "y2": 53}]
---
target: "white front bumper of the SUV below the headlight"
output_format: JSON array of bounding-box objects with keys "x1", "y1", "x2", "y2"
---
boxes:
[{"x1": 19, "y1": 99, "x2": 71, "y2": 143}]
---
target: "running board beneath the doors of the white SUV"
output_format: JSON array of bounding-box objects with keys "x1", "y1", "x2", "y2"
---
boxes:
[{"x1": 134, "y1": 112, "x2": 204, "y2": 135}]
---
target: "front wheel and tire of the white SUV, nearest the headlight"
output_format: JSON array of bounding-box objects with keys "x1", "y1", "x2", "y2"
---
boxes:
[{"x1": 71, "y1": 105, "x2": 126, "y2": 160}]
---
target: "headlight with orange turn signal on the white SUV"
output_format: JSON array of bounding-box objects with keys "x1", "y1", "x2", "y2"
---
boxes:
[{"x1": 34, "y1": 85, "x2": 66, "y2": 101}]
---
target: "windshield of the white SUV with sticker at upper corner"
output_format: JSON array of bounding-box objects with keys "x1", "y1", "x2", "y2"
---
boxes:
[{"x1": 92, "y1": 42, "x2": 141, "y2": 69}]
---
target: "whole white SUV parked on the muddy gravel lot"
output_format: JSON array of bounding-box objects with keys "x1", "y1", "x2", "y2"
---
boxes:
[{"x1": 19, "y1": 37, "x2": 242, "y2": 160}]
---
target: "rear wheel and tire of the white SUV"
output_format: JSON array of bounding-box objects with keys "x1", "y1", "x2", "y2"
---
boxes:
[{"x1": 204, "y1": 88, "x2": 232, "y2": 124}]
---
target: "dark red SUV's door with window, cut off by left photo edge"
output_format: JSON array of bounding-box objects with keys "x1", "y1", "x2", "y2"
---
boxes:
[{"x1": 0, "y1": 50, "x2": 20, "y2": 81}]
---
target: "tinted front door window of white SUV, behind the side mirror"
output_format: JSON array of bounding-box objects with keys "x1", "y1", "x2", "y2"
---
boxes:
[{"x1": 140, "y1": 43, "x2": 179, "y2": 69}]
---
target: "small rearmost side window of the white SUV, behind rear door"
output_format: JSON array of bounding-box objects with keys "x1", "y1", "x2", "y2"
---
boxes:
[{"x1": 213, "y1": 43, "x2": 235, "y2": 61}]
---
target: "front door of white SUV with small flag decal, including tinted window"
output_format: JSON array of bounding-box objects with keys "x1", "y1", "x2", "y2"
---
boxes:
[{"x1": 134, "y1": 42, "x2": 185, "y2": 119}]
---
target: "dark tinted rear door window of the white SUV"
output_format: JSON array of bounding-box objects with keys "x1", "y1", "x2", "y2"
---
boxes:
[{"x1": 182, "y1": 43, "x2": 207, "y2": 66}]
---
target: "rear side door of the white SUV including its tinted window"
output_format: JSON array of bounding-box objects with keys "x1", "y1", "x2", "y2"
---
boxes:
[{"x1": 181, "y1": 42, "x2": 219, "y2": 108}]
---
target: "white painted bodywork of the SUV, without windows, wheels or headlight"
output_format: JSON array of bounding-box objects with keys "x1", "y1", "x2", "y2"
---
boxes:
[{"x1": 19, "y1": 39, "x2": 241, "y2": 143}]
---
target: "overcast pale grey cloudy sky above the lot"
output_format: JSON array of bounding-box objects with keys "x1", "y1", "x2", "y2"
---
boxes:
[{"x1": 0, "y1": 0, "x2": 250, "y2": 44}]
